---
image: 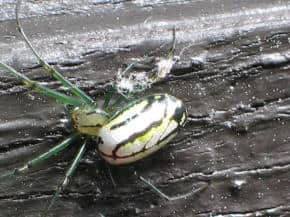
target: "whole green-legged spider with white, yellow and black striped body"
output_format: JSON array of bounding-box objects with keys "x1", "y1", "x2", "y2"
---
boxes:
[{"x1": 0, "y1": 0, "x2": 205, "y2": 215}]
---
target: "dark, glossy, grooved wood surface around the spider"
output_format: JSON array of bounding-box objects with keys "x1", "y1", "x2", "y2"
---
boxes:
[{"x1": 0, "y1": 0, "x2": 290, "y2": 217}]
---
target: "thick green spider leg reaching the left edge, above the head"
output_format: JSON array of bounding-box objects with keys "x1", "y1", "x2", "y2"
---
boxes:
[{"x1": 0, "y1": 62, "x2": 83, "y2": 106}]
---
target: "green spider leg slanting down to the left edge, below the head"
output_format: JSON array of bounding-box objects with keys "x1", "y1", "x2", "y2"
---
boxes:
[{"x1": 0, "y1": 134, "x2": 79, "y2": 179}]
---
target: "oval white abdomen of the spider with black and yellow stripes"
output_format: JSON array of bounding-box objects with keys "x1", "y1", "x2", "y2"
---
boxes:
[{"x1": 98, "y1": 94, "x2": 186, "y2": 164}]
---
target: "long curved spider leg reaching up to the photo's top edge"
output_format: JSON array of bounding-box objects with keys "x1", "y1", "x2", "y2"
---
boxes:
[{"x1": 15, "y1": 0, "x2": 95, "y2": 104}]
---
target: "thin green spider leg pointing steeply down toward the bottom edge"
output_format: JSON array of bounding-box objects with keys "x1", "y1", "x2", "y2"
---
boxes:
[{"x1": 43, "y1": 142, "x2": 86, "y2": 216}]
